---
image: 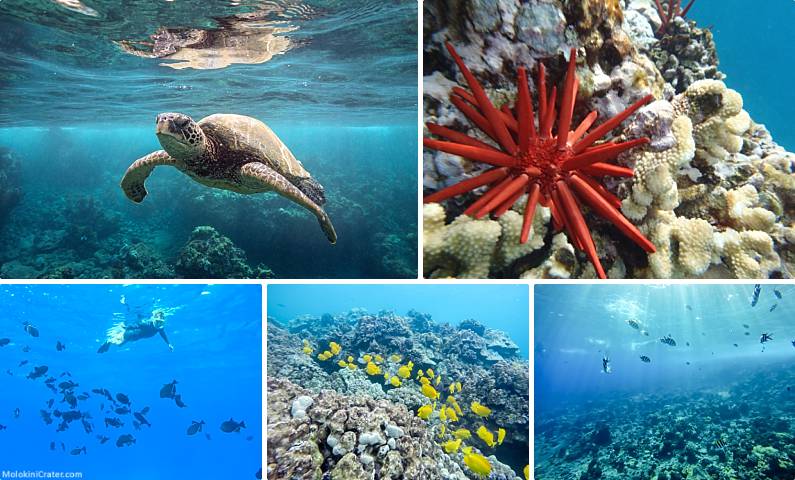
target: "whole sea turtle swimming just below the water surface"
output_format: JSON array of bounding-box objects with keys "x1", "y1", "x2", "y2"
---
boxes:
[{"x1": 121, "y1": 113, "x2": 337, "y2": 243}]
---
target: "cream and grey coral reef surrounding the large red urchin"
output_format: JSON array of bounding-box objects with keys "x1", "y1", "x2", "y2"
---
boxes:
[{"x1": 423, "y1": 0, "x2": 795, "y2": 278}]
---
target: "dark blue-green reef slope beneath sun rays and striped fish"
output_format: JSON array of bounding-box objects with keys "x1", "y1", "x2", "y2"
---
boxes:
[{"x1": 535, "y1": 363, "x2": 795, "y2": 480}]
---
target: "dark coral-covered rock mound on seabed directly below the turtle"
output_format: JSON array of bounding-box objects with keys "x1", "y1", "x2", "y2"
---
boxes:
[{"x1": 174, "y1": 226, "x2": 272, "y2": 278}]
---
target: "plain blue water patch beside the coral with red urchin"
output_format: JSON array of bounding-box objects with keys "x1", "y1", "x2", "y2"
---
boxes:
[{"x1": 683, "y1": 0, "x2": 795, "y2": 151}]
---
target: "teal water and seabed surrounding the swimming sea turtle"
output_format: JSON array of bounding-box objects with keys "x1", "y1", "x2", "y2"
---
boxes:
[{"x1": 0, "y1": 0, "x2": 418, "y2": 278}]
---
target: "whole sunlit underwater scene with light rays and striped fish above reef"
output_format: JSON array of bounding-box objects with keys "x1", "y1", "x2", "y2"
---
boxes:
[{"x1": 534, "y1": 284, "x2": 795, "y2": 479}]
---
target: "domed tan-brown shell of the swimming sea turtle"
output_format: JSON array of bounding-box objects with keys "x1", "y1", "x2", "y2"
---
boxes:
[{"x1": 199, "y1": 113, "x2": 311, "y2": 178}]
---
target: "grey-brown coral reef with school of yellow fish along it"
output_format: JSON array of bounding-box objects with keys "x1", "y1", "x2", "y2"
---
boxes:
[{"x1": 267, "y1": 310, "x2": 529, "y2": 480}]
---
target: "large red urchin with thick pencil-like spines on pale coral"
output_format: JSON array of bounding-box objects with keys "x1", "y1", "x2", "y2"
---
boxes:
[{"x1": 423, "y1": 43, "x2": 655, "y2": 278}]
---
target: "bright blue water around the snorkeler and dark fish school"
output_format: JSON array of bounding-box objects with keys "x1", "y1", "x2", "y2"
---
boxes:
[{"x1": 0, "y1": 285, "x2": 262, "y2": 480}]
